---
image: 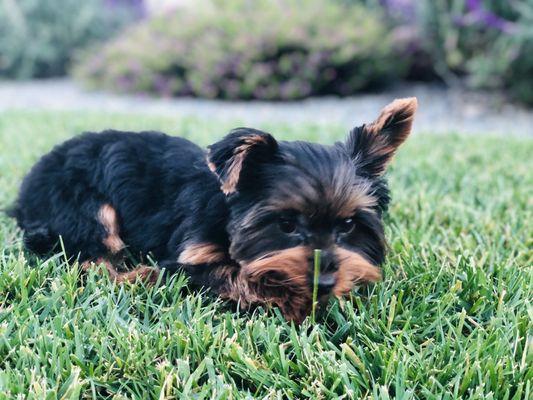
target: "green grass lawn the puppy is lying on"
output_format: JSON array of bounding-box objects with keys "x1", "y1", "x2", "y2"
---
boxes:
[{"x1": 0, "y1": 112, "x2": 533, "y2": 399}]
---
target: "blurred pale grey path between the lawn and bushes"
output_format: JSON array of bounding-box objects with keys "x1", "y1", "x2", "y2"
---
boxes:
[{"x1": 0, "y1": 79, "x2": 533, "y2": 137}]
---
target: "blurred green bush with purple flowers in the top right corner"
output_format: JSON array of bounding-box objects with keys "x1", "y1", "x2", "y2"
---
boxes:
[{"x1": 416, "y1": 0, "x2": 533, "y2": 105}]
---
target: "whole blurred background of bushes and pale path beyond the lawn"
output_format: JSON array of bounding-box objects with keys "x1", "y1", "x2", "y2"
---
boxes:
[{"x1": 0, "y1": 0, "x2": 533, "y2": 136}]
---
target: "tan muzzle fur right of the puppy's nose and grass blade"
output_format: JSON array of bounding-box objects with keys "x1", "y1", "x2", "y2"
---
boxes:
[{"x1": 333, "y1": 246, "x2": 381, "y2": 296}]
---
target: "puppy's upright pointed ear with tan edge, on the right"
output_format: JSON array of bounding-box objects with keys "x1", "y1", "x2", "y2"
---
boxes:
[{"x1": 345, "y1": 97, "x2": 418, "y2": 177}]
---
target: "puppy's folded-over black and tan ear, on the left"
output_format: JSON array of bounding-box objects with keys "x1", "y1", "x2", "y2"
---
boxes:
[{"x1": 207, "y1": 128, "x2": 278, "y2": 195}]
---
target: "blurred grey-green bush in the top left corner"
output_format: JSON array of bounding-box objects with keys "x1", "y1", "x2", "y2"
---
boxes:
[{"x1": 0, "y1": 0, "x2": 135, "y2": 79}]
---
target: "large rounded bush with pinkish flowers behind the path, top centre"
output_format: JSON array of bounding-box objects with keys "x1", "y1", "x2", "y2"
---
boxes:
[{"x1": 74, "y1": 0, "x2": 403, "y2": 100}]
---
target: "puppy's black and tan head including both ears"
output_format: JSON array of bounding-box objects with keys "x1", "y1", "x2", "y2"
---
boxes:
[{"x1": 208, "y1": 98, "x2": 417, "y2": 317}]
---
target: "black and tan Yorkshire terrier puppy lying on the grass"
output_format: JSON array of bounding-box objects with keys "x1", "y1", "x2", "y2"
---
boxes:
[{"x1": 11, "y1": 98, "x2": 417, "y2": 322}]
